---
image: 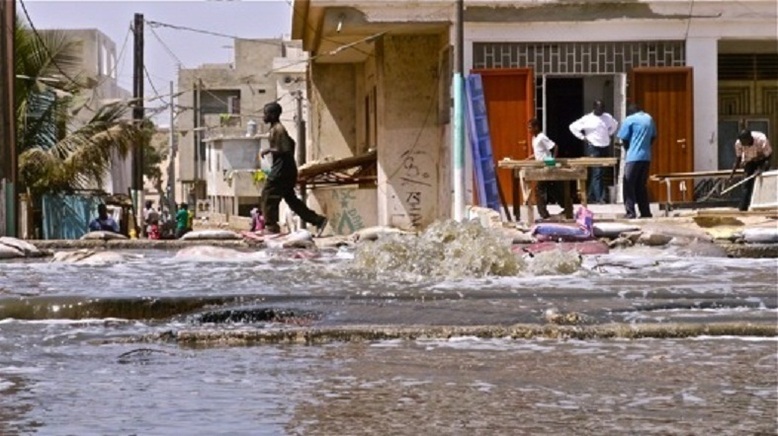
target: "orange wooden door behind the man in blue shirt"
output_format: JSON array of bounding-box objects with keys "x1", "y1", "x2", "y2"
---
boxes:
[{"x1": 629, "y1": 67, "x2": 694, "y2": 202}]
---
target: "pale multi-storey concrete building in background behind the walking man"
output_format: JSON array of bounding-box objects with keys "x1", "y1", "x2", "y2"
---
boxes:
[{"x1": 175, "y1": 39, "x2": 306, "y2": 215}]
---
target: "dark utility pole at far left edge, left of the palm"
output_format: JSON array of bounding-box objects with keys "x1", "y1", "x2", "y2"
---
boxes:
[{"x1": 0, "y1": 0, "x2": 18, "y2": 237}]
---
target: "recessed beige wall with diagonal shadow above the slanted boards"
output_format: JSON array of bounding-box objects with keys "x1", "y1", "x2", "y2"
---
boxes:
[{"x1": 309, "y1": 64, "x2": 357, "y2": 160}]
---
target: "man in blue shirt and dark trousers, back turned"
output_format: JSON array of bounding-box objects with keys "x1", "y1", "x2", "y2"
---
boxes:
[{"x1": 618, "y1": 103, "x2": 656, "y2": 218}]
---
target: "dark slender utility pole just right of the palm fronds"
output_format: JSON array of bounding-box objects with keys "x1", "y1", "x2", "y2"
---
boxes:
[{"x1": 132, "y1": 13, "x2": 145, "y2": 232}]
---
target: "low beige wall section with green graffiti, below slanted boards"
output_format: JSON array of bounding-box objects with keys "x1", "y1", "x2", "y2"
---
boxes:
[{"x1": 309, "y1": 186, "x2": 378, "y2": 235}]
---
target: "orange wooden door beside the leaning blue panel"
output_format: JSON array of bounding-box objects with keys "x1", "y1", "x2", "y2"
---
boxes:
[{"x1": 472, "y1": 68, "x2": 535, "y2": 203}]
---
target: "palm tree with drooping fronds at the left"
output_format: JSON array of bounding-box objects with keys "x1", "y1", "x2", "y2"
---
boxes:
[{"x1": 14, "y1": 20, "x2": 147, "y2": 200}]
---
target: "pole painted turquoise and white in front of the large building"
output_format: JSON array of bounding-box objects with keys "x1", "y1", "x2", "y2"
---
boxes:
[{"x1": 452, "y1": 0, "x2": 465, "y2": 221}]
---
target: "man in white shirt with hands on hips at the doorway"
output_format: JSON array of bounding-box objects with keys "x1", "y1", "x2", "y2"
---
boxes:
[{"x1": 570, "y1": 100, "x2": 619, "y2": 203}]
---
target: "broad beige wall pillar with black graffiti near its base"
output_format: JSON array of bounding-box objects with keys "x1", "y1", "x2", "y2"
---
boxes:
[{"x1": 376, "y1": 35, "x2": 448, "y2": 228}]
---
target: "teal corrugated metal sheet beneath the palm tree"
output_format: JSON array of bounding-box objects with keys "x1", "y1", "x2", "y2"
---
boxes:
[{"x1": 42, "y1": 195, "x2": 101, "y2": 239}]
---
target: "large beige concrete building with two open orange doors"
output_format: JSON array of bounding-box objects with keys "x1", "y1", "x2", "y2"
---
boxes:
[{"x1": 292, "y1": 0, "x2": 778, "y2": 227}]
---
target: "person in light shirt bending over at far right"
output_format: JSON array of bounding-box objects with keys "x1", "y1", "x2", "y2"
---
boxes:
[{"x1": 729, "y1": 129, "x2": 773, "y2": 211}]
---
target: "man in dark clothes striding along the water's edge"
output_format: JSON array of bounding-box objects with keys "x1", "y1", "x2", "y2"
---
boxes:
[{"x1": 260, "y1": 102, "x2": 327, "y2": 237}]
